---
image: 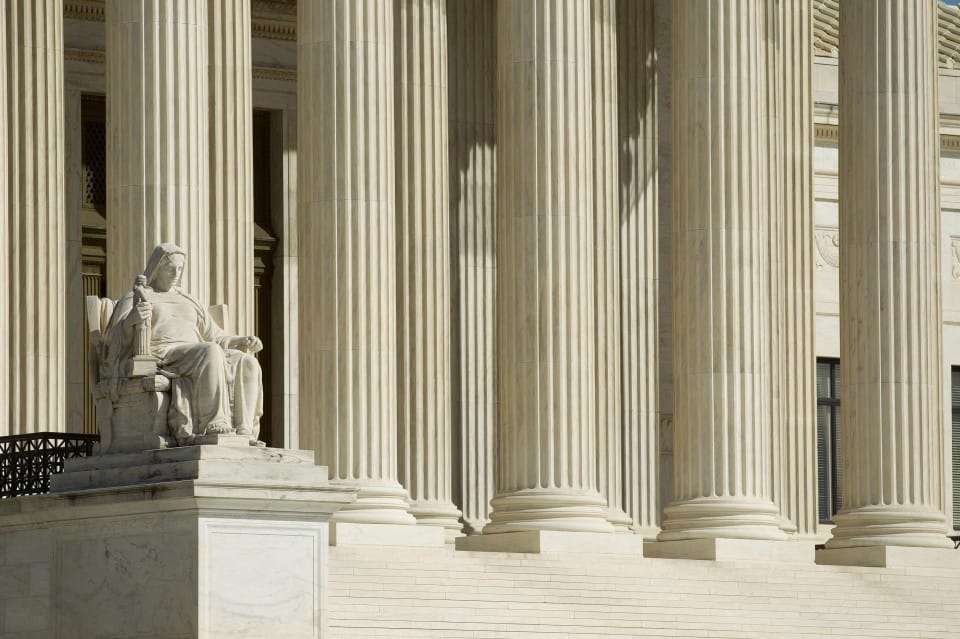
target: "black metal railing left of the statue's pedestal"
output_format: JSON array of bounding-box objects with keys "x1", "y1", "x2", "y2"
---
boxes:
[{"x1": 0, "y1": 433, "x2": 100, "y2": 499}]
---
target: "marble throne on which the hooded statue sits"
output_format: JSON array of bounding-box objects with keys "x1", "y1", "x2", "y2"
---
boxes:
[{"x1": 85, "y1": 295, "x2": 236, "y2": 454}]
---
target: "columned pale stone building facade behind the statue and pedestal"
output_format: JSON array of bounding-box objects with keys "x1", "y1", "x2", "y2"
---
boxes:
[{"x1": 0, "y1": 0, "x2": 960, "y2": 636}]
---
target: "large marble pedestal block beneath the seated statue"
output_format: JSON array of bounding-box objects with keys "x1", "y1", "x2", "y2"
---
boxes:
[{"x1": 0, "y1": 446, "x2": 355, "y2": 639}]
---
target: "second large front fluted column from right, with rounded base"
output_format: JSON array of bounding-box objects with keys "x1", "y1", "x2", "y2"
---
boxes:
[{"x1": 659, "y1": 0, "x2": 785, "y2": 541}]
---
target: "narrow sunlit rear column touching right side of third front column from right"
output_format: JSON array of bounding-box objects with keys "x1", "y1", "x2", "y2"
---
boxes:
[{"x1": 591, "y1": 0, "x2": 632, "y2": 532}]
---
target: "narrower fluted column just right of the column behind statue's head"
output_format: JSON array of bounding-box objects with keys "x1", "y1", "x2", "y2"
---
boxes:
[{"x1": 207, "y1": 0, "x2": 254, "y2": 335}]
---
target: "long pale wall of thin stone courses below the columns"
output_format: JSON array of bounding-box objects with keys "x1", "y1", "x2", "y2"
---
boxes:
[{"x1": 327, "y1": 548, "x2": 960, "y2": 639}]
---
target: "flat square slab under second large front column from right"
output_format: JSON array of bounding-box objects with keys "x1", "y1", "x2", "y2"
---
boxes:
[{"x1": 643, "y1": 538, "x2": 814, "y2": 564}]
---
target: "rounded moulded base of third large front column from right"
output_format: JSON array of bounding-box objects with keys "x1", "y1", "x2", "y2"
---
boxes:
[{"x1": 483, "y1": 488, "x2": 613, "y2": 535}]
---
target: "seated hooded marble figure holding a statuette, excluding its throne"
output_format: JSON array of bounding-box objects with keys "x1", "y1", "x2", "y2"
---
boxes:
[{"x1": 100, "y1": 244, "x2": 263, "y2": 446}]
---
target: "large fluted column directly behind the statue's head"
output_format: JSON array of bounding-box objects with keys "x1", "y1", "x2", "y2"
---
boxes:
[{"x1": 106, "y1": 0, "x2": 210, "y2": 302}]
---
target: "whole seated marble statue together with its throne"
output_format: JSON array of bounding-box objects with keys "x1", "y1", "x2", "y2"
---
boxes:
[{"x1": 88, "y1": 244, "x2": 263, "y2": 452}]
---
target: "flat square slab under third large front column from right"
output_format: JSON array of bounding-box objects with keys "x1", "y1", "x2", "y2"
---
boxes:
[{"x1": 456, "y1": 530, "x2": 643, "y2": 558}]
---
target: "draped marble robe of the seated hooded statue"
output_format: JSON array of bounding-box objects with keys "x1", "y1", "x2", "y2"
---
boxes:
[{"x1": 105, "y1": 287, "x2": 263, "y2": 444}]
